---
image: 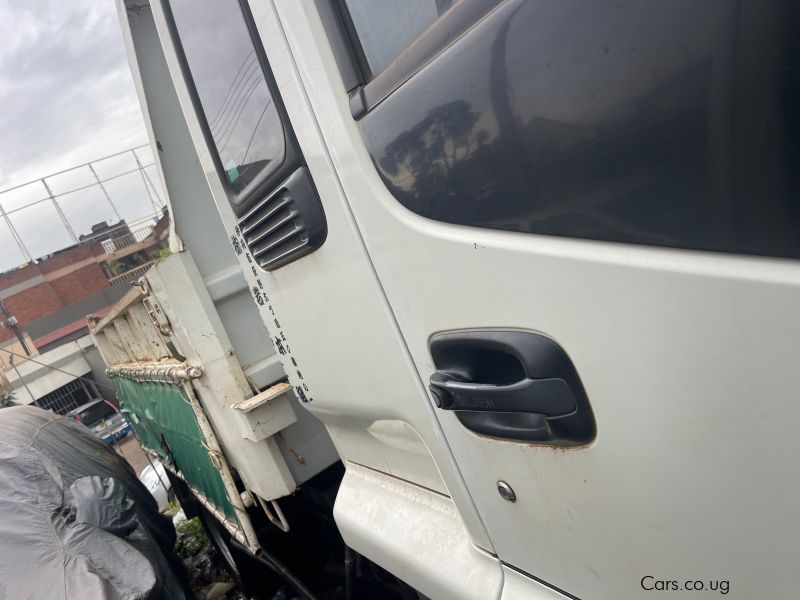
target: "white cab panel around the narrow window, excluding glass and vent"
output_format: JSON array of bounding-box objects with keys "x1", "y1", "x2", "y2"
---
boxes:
[{"x1": 143, "y1": 2, "x2": 499, "y2": 572}]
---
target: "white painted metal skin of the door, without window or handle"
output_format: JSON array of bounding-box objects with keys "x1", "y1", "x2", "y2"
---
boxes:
[{"x1": 277, "y1": 1, "x2": 800, "y2": 598}]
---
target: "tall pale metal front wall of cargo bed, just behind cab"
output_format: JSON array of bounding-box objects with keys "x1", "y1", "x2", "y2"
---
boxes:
[{"x1": 117, "y1": 0, "x2": 338, "y2": 483}]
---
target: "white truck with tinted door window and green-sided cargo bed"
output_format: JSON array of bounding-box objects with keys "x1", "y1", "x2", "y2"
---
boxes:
[{"x1": 93, "y1": 0, "x2": 800, "y2": 600}]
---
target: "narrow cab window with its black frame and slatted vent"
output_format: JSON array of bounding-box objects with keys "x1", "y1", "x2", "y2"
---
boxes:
[{"x1": 162, "y1": 0, "x2": 328, "y2": 271}]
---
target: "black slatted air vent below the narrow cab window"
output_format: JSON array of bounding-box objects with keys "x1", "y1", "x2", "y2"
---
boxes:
[{"x1": 239, "y1": 167, "x2": 327, "y2": 270}]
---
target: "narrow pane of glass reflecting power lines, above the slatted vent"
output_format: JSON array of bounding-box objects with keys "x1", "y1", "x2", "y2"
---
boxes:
[{"x1": 170, "y1": 0, "x2": 286, "y2": 193}]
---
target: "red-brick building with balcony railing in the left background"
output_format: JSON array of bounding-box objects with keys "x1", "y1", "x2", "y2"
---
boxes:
[{"x1": 0, "y1": 212, "x2": 169, "y2": 414}]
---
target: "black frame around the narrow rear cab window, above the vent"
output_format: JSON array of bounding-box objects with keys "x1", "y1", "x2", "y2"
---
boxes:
[{"x1": 160, "y1": 0, "x2": 305, "y2": 218}]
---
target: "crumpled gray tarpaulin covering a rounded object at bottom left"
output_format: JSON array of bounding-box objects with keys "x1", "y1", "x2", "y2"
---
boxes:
[{"x1": 0, "y1": 406, "x2": 187, "y2": 600}]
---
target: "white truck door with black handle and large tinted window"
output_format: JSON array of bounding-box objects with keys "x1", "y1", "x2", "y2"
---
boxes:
[{"x1": 276, "y1": 0, "x2": 800, "y2": 598}]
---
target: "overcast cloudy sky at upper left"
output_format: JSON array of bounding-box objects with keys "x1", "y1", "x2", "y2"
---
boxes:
[{"x1": 0, "y1": 0, "x2": 161, "y2": 271}]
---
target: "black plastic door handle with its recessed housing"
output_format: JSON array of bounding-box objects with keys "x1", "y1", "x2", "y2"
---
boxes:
[{"x1": 430, "y1": 331, "x2": 596, "y2": 446}]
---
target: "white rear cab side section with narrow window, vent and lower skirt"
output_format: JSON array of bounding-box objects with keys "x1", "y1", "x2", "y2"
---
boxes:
[{"x1": 140, "y1": 0, "x2": 504, "y2": 600}]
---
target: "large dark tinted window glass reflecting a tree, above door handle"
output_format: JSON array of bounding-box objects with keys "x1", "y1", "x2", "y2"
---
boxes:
[{"x1": 360, "y1": 0, "x2": 800, "y2": 258}]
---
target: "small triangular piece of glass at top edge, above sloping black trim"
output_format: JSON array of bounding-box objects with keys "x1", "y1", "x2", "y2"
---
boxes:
[{"x1": 344, "y1": 0, "x2": 454, "y2": 73}]
